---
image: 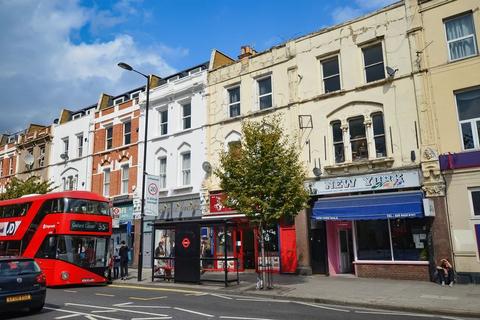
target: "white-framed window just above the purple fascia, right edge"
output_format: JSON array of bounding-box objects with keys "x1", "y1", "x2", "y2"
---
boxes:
[{"x1": 455, "y1": 88, "x2": 480, "y2": 150}]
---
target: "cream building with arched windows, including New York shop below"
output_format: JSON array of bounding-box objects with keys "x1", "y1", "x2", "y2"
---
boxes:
[{"x1": 207, "y1": 2, "x2": 448, "y2": 280}]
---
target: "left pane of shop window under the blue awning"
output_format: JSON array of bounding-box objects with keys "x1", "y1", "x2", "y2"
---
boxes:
[{"x1": 356, "y1": 220, "x2": 392, "y2": 260}]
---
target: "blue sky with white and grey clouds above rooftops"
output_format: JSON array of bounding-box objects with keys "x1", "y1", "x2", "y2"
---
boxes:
[{"x1": 0, "y1": 0, "x2": 396, "y2": 133}]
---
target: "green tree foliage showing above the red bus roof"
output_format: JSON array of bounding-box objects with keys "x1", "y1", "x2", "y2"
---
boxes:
[{"x1": 0, "y1": 176, "x2": 54, "y2": 200}]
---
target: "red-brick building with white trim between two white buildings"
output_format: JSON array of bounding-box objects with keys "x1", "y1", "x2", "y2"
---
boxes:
[{"x1": 91, "y1": 87, "x2": 144, "y2": 264}]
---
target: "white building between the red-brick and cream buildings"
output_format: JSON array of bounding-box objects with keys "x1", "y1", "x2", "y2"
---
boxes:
[{"x1": 138, "y1": 63, "x2": 208, "y2": 267}]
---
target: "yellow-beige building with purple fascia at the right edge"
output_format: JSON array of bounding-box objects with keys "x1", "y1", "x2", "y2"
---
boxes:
[{"x1": 412, "y1": 0, "x2": 480, "y2": 283}]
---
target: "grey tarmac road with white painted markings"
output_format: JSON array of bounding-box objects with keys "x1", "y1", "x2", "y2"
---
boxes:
[{"x1": 1, "y1": 285, "x2": 478, "y2": 320}]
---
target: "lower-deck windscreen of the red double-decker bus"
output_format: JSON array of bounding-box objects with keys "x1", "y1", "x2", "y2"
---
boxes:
[{"x1": 36, "y1": 235, "x2": 108, "y2": 268}]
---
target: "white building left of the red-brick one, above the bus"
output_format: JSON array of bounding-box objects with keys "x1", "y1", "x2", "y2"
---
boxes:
[{"x1": 49, "y1": 105, "x2": 96, "y2": 191}]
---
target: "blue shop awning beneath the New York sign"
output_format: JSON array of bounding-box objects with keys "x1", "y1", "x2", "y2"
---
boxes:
[{"x1": 312, "y1": 191, "x2": 424, "y2": 220}]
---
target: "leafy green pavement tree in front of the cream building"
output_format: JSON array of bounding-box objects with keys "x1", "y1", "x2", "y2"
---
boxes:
[{"x1": 214, "y1": 115, "x2": 308, "y2": 287}]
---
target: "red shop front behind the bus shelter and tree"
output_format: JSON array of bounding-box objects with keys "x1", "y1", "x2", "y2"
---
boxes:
[{"x1": 204, "y1": 193, "x2": 297, "y2": 273}]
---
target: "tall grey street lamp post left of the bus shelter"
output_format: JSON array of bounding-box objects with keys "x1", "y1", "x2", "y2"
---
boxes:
[{"x1": 118, "y1": 62, "x2": 150, "y2": 281}]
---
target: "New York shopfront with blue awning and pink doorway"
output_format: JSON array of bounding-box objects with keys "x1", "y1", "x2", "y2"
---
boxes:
[{"x1": 309, "y1": 171, "x2": 433, "y2": 280}]
